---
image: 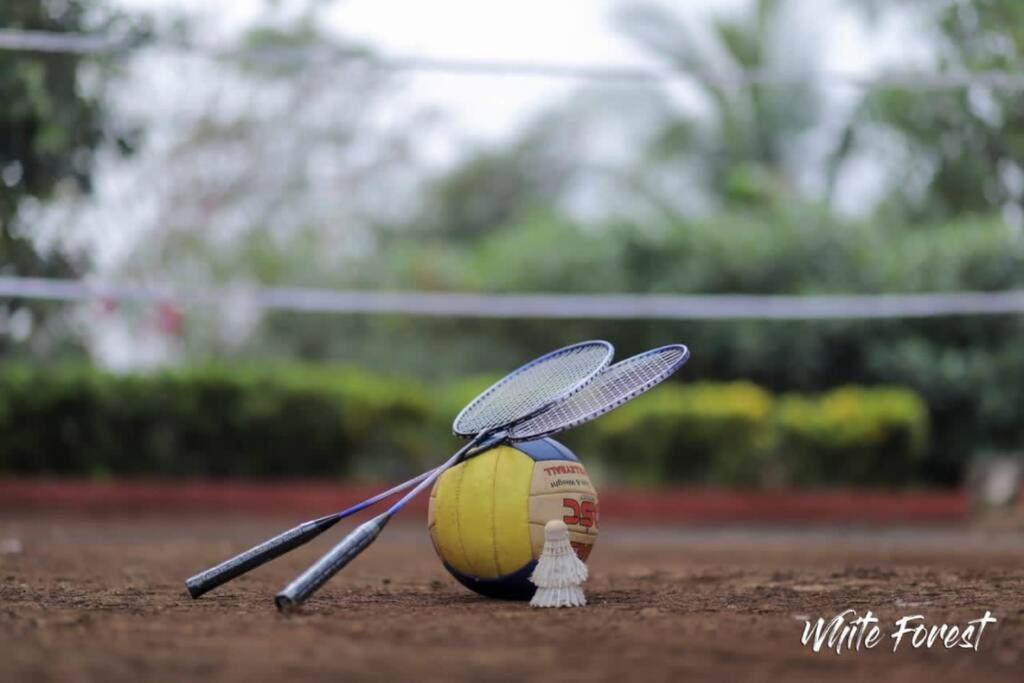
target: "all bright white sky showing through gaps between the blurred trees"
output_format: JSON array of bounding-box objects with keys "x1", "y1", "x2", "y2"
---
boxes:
[{"x1": 105, "y1": 0, "x2": 928, "y2": 213}]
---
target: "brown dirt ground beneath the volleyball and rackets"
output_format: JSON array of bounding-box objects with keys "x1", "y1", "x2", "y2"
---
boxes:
[{"x1": 0, "y1": 512, "x2": 1024, "y2": 683}]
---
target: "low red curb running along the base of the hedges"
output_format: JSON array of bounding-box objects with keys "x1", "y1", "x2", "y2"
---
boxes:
[{"x1": 0, "y1": 478, "x2": 970, "y2": 524}]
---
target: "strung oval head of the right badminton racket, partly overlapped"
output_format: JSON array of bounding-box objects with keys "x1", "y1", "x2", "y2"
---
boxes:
[{"x1": 509, "y1": 344, "x2": 690, "y2": 441}]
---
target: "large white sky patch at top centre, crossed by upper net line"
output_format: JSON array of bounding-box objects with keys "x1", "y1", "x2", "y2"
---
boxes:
[{"x1": 321, "y1": 0, "x2": 671, "y2": 137}]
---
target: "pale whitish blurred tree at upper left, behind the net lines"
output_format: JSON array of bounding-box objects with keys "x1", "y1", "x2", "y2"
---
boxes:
[{"x1": 35, "y1": 2, "x2": 434, "y2": 366}]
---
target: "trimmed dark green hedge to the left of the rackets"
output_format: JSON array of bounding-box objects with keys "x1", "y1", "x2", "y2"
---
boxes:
[{"x1": 0, "y1": 367, "x2": 443, "y2": 476}]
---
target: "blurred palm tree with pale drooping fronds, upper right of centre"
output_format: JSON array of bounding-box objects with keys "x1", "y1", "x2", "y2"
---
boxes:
[{"x1": 621, "y1": 0, "x2": 822, "y2": 205}]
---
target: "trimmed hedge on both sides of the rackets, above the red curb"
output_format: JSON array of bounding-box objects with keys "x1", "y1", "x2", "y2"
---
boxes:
[{"x1": 0, "y1": 367, "x2": 928, "y2": 485}]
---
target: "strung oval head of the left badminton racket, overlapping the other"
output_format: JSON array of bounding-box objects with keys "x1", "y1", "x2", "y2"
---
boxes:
[{"x1": 453, "y1": 341, "x2": 613, "y2": 436}]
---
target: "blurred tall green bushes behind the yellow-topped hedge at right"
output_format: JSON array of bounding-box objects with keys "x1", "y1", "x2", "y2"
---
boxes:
[{"x1": 303, "y1": 206, "x2": 1024, "y2": 483}]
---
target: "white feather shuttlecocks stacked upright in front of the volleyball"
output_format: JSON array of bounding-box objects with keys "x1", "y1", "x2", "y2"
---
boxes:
[{"x1": 529, "y1": 519, "x2": 587, "y2": 607}]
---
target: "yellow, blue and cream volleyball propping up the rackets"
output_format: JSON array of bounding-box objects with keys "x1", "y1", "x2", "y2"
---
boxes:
[{"x1": 427, "y1": 438, "x2": 598, "y2": 600}]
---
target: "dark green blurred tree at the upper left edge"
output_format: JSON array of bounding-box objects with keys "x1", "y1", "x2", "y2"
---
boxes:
[{"x1": 0, "y1": 0, "x2": 142, "y2": 353}]
